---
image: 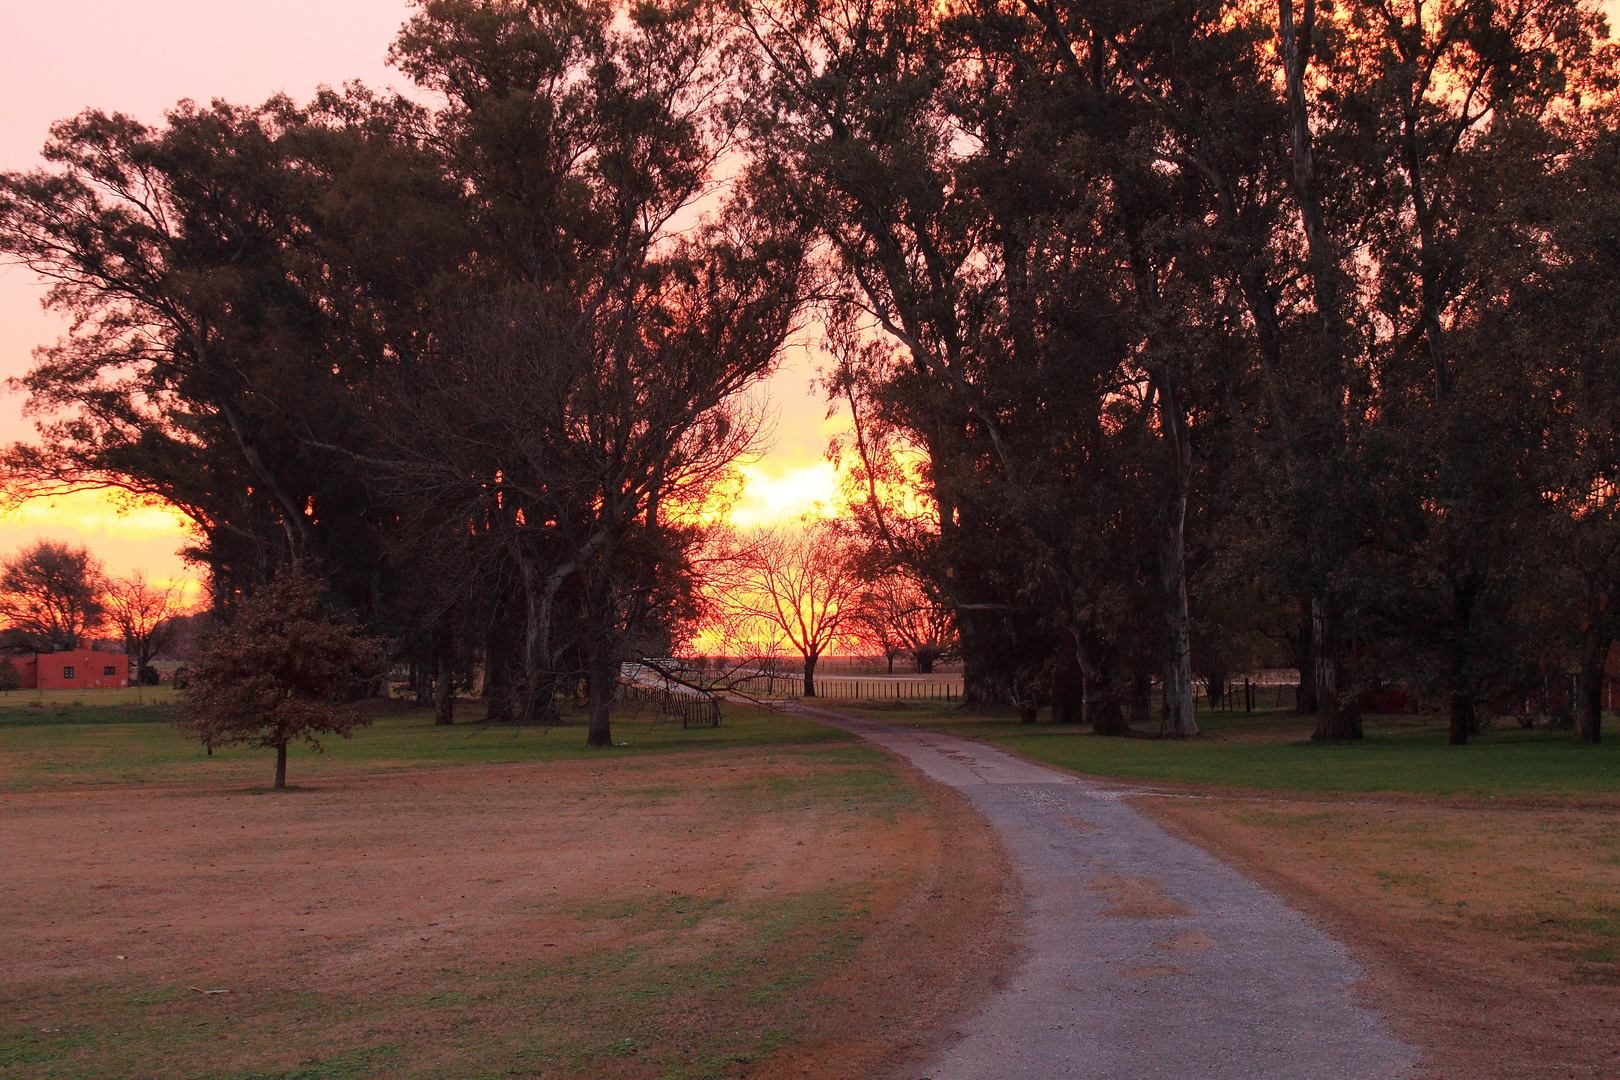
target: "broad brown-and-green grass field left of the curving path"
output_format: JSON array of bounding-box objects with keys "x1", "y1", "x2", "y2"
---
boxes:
[{"x1": 0, "y1": 709, "x2": 1006, "y2": 1080}]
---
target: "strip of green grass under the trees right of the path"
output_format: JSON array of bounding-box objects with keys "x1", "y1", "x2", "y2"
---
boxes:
[{"x1": 826, "y1": 701, "x2": 1620, "y2": 797}]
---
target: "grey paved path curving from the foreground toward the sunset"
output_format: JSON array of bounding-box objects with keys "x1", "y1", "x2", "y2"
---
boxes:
[{"x1": 797, "y1": 706, "x2": 1419, "y2": 1080}]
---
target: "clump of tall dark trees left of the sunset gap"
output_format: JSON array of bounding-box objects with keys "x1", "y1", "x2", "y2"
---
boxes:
[{"x1": 0, "y1": 0, "x2": 805, "y2": 745}]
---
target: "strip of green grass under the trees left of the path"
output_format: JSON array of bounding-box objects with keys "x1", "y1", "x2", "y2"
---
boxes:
[{"x1": 0, "y1": 690, "x2": 851, "y2": 792}]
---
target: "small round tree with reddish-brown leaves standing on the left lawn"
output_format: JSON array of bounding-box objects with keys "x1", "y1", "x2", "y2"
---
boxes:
[{"x1": 185, "y1": 568, "x2": 384, "y2": 787}]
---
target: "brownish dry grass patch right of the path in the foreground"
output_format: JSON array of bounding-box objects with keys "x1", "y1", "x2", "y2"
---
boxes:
[{"x1": 1132, "y1": 793, "x2": 1620, "y2": 1080}]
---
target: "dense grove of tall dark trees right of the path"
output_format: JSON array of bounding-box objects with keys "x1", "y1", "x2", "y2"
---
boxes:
[{"x1": 739, "y1": 0, "x2": 1615, "y2": 742}]
